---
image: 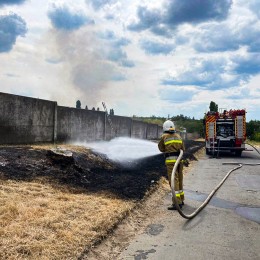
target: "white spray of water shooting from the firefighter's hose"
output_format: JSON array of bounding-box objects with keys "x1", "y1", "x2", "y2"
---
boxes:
[{"x1": 85, "y1": 137, "x2": 160, "y2": 165}]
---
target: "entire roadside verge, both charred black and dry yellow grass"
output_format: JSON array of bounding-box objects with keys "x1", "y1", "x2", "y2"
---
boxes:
[{"x1": 0, "y1": 141, "x2": 203, "y2": 259}]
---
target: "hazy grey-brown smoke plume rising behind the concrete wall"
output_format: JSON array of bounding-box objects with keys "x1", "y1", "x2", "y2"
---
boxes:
[{"x1": 53, "y1": 28, "x2": 114, "y2": 108}]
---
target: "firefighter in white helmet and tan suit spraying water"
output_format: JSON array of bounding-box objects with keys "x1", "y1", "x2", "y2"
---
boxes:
[{"x1": 158, "y1": 120, "x2": 185, "y2": 210}]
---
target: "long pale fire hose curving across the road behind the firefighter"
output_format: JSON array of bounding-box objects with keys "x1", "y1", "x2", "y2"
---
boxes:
[{"x1": 171, "y1": 144, "x2": 260, "y2": 219}]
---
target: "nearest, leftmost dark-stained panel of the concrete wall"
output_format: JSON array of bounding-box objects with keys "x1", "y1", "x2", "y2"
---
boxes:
[{"x1": 0, "y1": 93, "x2": 57, "y2": 144}]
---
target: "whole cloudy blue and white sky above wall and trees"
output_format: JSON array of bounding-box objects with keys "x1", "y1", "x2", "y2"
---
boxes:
[{"x1": 0, "y1": 0, "x2": 260, "y2": 121}]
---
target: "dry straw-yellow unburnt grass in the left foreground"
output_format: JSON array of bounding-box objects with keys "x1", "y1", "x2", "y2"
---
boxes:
[{"x1": 0, "y1": 180, "x2": 134, "y2": 259}]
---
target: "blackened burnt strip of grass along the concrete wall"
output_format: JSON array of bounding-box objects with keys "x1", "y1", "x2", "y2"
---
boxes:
[{"x1": 0, "y1": 140, "x2": 204, "y2": 200}]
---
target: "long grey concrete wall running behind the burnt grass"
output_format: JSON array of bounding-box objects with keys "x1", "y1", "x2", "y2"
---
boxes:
[{"x1": 0, "y1": 92, "x2": 162, "y2": 144}]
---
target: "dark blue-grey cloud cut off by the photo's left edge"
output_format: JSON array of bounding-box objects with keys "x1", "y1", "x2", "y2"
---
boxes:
[{"x1": 0, "y1": 13, "x2": 27, "y2": 52}]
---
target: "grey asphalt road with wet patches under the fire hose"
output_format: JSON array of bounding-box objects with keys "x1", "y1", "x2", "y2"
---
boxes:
[{"x1": 119, "y1": 146, "x2": 260, "y2": 260}]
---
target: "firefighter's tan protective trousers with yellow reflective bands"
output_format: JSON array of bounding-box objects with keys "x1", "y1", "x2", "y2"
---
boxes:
[{"x1": 166, "y1": 162, "x2": 184, "y2": 205}]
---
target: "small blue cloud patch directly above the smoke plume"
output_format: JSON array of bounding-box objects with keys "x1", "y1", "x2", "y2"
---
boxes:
[{"x1": 48, "y1": 5, "x2": 95, "y2": 31}]
